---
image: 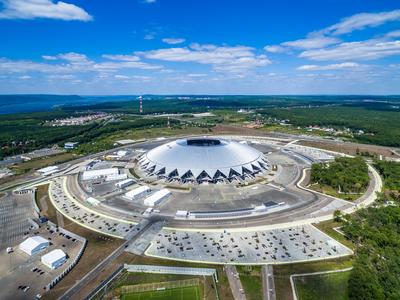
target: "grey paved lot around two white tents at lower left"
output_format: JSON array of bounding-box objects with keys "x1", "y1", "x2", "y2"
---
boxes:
[{"x1": 0, "y1": 225, "x2": 82, "y2": 299}]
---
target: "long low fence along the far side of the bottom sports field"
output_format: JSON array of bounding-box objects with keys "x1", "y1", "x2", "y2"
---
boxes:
[{"x1": 121, "y1": 278, "x2": 200, "y2": 294}]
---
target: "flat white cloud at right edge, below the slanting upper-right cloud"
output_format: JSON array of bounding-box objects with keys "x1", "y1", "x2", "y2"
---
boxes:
[{"x1": 300, "y1": 40, "x2": 400, "y2": 61}]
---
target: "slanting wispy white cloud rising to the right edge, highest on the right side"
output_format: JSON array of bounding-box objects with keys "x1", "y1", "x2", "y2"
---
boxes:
[{"x1": 321, "y1": 9, "x2": 400, "y2": 35}]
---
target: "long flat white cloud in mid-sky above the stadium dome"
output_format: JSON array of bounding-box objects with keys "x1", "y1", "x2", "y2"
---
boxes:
[{"x1": 136, "y1": 44, "x2": 271, "y2": 72}]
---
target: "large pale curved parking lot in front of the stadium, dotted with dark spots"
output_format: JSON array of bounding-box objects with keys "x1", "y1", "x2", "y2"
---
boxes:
[{"x1": 146, "y1": 225, "x2": 352, "y2": 264}]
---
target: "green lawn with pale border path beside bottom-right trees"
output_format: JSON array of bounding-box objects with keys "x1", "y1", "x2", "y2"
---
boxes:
[{"x1": 294, "y1": 271, "x2": 350, "y2": 300}]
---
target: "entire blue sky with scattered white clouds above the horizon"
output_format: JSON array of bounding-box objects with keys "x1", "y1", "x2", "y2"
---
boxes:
[{"x1": 0, "y1": 0, "x2": 400, "y2": 95}]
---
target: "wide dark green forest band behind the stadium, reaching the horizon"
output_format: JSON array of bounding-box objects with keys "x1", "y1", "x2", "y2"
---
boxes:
[{"x1": 0, "y1": 95, "x2": 400, "y2": 159}]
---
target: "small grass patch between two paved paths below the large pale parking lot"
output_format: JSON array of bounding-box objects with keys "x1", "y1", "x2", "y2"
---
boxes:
[{"x1": 236, "y1": 266, "x2": 263, "y2": 300}]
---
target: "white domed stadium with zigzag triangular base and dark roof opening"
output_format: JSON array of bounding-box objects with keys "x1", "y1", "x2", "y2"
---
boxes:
[{"x1": 139, "y1": 137, "x2": 268, "y2": 183}]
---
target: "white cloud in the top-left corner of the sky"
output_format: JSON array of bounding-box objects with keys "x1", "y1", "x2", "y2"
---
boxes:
[{"x1": 0, "y1": 0, "x2": 93, "y2": 21}]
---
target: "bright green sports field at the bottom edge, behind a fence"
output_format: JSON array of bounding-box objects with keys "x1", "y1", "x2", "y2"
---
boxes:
[{"x1": 121, "y1": 286, "x2": 200, "y2": 300}]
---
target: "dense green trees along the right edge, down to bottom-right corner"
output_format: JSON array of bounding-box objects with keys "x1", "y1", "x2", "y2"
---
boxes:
[{"x1": 342, "y1": 161, "x2": 400, "y2": 300}]
